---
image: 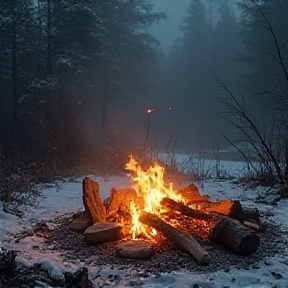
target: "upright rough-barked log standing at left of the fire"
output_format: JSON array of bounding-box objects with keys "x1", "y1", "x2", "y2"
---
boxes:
[{"x1": 82, "y1": 177, "x2": 106, "y2": 223}]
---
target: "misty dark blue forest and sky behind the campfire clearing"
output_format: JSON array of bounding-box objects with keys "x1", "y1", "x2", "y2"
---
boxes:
[{"x1": 0, "y1": 0, "x2": 288, "y2": 173}]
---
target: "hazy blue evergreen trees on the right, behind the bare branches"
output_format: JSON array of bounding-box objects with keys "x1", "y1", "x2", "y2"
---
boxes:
[{"x1": 163, "y1": 0, "x2": 288, "y2": 153}]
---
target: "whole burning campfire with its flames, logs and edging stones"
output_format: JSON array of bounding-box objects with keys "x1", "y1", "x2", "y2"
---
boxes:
[{"x1": 69, "y1": 156, "x2": 261, "y2": 265}]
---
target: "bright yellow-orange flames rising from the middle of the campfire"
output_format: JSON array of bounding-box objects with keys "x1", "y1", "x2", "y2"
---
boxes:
[{"x1": 125, "y1": 156, "x2": 181, "y2": 239}]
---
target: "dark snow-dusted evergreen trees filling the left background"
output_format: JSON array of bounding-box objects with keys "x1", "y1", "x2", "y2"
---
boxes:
[{"x1": 0, "y1": 0, "x2": 163, "y2": 173}]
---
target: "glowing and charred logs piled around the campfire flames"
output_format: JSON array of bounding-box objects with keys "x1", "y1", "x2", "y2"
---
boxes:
[{"x1": 70, "y1": 177, "x2": 261, "y2": 264}]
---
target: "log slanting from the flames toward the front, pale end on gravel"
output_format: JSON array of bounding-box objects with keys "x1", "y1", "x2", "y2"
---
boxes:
[{"x1": 139, "y1": 212, "x2": 211, "y2": 265}]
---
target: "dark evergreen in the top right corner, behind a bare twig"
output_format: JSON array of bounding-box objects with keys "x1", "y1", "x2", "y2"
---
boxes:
[{"x1": 240, "y1": 0, "x2": 288, "y2": 94}]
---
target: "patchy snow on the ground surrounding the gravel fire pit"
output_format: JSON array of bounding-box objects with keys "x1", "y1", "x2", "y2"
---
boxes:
[{"x1": 0, "y1": 163, "x2": 288, "y2": 288}]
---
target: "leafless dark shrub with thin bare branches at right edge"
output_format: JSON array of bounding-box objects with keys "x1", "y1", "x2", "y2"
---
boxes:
[{"x1": 216, "y1": 1, "x2": 288, "y2": 189}]
